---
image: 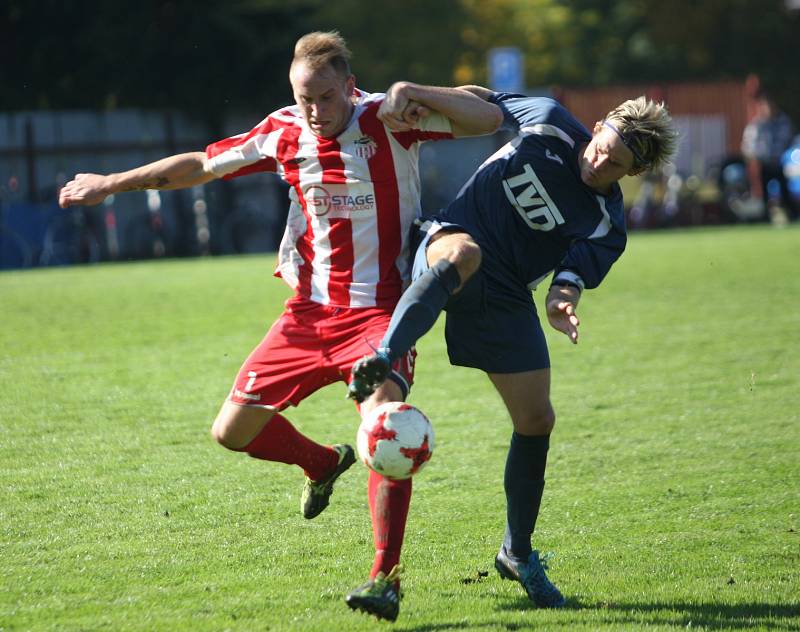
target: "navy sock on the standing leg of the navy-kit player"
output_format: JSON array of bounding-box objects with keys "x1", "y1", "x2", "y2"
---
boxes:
[{"x1": 503, "y1": 432, "x2": 550, "y2": 560}]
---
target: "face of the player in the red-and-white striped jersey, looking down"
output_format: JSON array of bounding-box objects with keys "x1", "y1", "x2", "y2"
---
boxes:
[{"x1": 289, "y1": 62, "x2": 355, "y2": 137}]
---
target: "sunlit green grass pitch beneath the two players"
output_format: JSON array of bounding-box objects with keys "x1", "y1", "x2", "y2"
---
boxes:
[{"x1": 0, "y1": 226, "x2": 800, "y2": 632}]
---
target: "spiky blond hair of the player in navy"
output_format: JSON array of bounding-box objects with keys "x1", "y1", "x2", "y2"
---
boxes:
[{"x1": 603, "y1": 96, "x2": 678, "y2": 173}]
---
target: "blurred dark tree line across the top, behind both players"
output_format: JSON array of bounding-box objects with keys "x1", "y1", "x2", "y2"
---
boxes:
[{"x1": 0, "y1": 0, "x2": 800, "y2": 122}]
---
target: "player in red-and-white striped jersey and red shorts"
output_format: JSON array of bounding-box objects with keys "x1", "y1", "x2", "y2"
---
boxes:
[{"x1": 60, "y1": 32, "x2": 501, "y2": 620}]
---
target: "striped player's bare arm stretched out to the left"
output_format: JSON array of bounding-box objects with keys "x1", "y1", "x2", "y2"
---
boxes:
[{"x1": 58, "y1": 151, "x2": 217, "y2": 208}]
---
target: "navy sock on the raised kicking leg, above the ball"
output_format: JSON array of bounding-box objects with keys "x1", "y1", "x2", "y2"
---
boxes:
[{"x1": 380, "y1": 259, "x2": 461, "y2": 360}]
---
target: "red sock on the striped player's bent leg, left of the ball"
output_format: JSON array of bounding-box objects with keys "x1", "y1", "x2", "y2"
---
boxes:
[{"x1": 242, "y1": 413, "x2": 339, "y2": 481}]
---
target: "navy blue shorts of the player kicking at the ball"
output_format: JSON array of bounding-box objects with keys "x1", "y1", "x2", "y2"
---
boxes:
[{"x1": 412, "y1": 221, "x2": 550, "y2": 373}]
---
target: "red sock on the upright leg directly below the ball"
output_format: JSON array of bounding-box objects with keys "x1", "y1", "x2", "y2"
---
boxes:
[{"x1": 369, "y1": 470, "x2": 411, "y2": 578}]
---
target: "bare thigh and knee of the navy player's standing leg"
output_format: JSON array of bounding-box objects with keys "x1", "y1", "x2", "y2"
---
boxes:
[{"x1": 488, "y1": 369, "x2": 555, "y2": 435}]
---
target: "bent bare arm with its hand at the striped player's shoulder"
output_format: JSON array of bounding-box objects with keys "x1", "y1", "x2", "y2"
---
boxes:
[{"x1": 378, "y1": 81, "x2": 503, "y2": 136}]
